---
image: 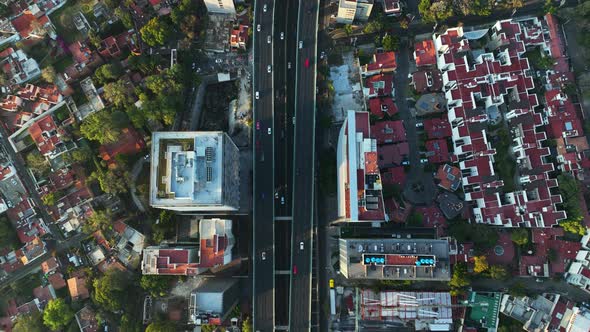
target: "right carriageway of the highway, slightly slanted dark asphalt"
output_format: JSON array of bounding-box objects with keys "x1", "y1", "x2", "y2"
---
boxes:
[{"x1": 289, "y1": 0, "x2": 319, "y2": 331}]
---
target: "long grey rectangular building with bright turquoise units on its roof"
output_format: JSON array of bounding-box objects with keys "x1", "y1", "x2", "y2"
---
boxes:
[{"x1": 339, "y1": 238, "x2": 451, "y2": 281}]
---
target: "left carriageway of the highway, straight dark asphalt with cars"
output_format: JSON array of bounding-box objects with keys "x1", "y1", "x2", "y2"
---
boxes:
[{"x1": 252, "y1": 0, "x2": 276, "y2": 331}]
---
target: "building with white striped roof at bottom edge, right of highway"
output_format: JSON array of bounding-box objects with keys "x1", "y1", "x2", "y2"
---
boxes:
[{"x1": 358, "y1": 289, "x2": 456, "y2": 331}]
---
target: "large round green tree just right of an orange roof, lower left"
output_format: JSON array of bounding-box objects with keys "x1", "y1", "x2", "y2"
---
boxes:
[{"x1": 92, "y1": 268, "x2": 129, "y2": 312}]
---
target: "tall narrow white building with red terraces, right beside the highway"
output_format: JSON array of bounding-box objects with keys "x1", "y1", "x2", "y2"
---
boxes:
[{"x1": 336, "y1": 111, "x2": 388, "y2": 222}]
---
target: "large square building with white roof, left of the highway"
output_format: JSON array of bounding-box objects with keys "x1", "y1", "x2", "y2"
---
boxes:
[{"x1": 150, "y1": 132, "x2": 240, "y2": 213}]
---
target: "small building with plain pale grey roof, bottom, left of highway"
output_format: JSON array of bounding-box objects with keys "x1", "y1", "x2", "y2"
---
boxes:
[{"x1": 188, "y1": 278, "x2": 240, "y2": 325}]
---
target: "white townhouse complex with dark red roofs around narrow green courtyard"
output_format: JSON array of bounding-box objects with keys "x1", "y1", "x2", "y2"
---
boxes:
[{"x1": 435, "y1": 20, "x2": 566, "y2": 227}]
